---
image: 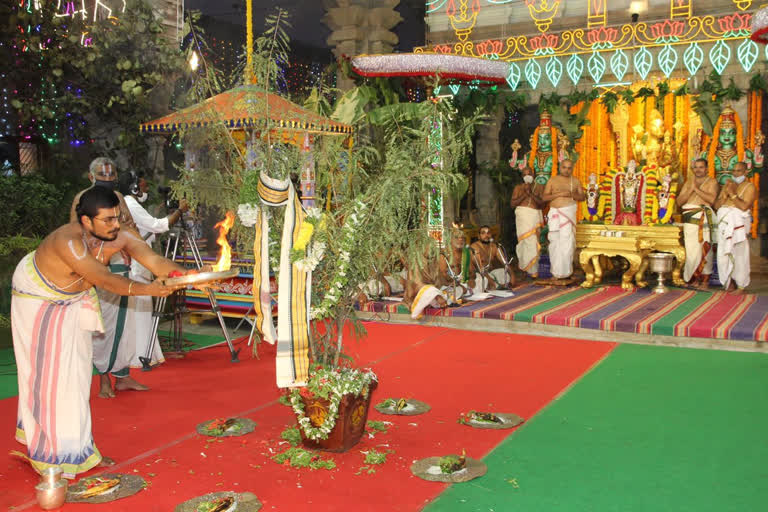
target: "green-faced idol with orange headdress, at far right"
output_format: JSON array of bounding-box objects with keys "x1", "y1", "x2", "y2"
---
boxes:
[{"x1": 701, "y1": 106, "x2": 764, "y2": 186}]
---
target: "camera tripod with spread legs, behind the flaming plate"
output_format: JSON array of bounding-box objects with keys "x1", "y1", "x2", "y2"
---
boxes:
[{"x1": 139, "y1": 226, "x2": 240, "y2": 372}]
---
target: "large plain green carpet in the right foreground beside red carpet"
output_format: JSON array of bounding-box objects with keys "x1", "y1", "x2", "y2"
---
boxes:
[{"x1": 426, "y1": 345, "x2": 768, "y2": 512}]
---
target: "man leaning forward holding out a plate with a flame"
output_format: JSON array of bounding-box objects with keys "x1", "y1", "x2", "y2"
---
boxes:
[{"x1": 11, "y1": 187, "x2": 189, "y2": 478}]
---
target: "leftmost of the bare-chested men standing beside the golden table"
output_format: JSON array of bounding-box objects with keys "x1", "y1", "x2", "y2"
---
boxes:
[{"x1": 510, "y1": 166, "x2": 544, "y2": 278}]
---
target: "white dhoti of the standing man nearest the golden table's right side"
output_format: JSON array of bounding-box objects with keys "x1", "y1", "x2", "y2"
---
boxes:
[{"x1": 682, "y1": 204, "x2": 714, "y2": 282}]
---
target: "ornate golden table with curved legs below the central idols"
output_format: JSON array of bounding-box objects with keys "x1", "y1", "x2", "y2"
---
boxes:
[{"x1": 576, "y1": 223, "x2": 685, "y2": 290}]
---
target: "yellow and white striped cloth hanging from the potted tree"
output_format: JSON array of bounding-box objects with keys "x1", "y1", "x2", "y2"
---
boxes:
[{"x1": 253, "y1": 172, "x2": 312, "y2": 388}]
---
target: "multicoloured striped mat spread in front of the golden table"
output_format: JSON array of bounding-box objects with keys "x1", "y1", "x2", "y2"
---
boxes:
[{"x1": 356, "y1": 285, "x2": 768, "y2": 341}]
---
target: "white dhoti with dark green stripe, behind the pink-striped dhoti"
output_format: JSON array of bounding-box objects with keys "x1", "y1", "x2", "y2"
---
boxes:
[{"x1": 93, "y1": 253, "x2": 136, "y2": 378}]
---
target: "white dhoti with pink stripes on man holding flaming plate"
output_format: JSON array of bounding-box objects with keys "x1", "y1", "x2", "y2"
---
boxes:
[{"x1": 11, "y1": 252, "x2": 103, "y2": 478}]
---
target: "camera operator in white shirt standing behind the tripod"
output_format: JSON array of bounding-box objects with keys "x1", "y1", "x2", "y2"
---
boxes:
[{"x1": 122, "y1": 171, "x2": 189, "y2": 372}]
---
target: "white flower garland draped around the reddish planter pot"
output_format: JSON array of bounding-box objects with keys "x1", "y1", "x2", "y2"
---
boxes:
[{"x1": 290, "y1": 365, "x2": 378, "y2": 441}]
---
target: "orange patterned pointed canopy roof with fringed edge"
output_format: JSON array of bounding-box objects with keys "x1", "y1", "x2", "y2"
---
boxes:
[{"x1": 139, "y1": 85, "x2": 352, "y2": 135}]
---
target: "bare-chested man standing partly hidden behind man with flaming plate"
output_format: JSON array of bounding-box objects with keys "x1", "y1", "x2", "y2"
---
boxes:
[{"x1": 69, "y1": 157, "x2": 149, "y2": 398}]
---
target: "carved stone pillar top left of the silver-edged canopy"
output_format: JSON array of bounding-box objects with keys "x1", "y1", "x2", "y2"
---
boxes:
[{"x1": 323, "y1": 0, "x2": 403, "y2": 89}]
